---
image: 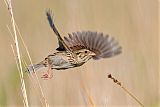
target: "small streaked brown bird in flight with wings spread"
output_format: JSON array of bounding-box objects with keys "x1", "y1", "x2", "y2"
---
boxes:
[{"x1": 27, "y1": 10, "x2": 122, "y2": 79}]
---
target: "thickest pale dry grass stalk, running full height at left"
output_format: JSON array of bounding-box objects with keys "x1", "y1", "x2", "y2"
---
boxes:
[{"x1": 5, "y1": 0, "x2": 29, "y2": 107}]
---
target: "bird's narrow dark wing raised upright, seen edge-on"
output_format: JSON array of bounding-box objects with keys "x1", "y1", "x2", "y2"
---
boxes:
[{"x1": 46, "y1": 9, "x2": 71, "y2": 51}]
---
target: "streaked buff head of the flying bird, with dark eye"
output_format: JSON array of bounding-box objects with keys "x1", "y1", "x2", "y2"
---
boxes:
[{"x1": 76, "y1": 49, "x2": 96, "y2": 62}]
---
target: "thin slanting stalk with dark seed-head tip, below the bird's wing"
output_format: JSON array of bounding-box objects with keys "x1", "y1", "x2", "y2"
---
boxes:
[{"x1": 108, "y1": 74, "x2": 144, "y2": 107}]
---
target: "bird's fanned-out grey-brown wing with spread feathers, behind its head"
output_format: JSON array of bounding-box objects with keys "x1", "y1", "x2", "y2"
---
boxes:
[{"x1": 64, "y1": 31, "x2": 122, "y2": 59}]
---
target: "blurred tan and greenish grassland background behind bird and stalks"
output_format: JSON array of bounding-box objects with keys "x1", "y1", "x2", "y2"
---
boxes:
[{"x1": 0, "y1": 0, "x2": 160, "y2": 107}]
